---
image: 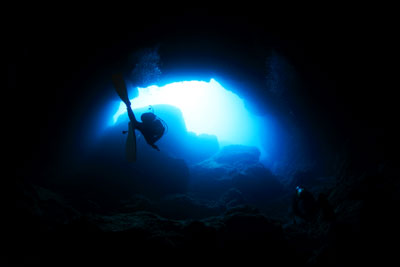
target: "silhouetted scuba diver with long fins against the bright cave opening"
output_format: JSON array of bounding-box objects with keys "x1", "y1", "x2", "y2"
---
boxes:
[{"x1": 112, "y1": 74, "x2": 166, "y2": 162}]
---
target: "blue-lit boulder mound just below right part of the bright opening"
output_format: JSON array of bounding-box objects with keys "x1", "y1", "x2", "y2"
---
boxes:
[{"x1": 189, "y1": 145, "x2": 284, "y2": 207}]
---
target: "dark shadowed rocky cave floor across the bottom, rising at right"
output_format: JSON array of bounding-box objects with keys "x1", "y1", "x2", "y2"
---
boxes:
[{"x1": 12, "y1": 157, "x2": 399, "y2": 266}]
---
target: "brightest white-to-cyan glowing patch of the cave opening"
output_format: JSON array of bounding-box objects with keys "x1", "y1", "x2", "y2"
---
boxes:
[{"x1": 113, "y1": 79, "x2": 262, "y2": 150}]
